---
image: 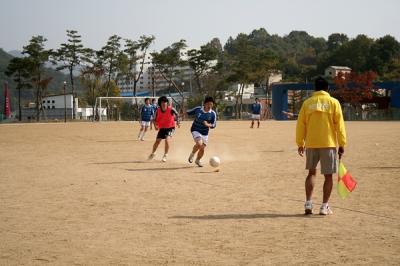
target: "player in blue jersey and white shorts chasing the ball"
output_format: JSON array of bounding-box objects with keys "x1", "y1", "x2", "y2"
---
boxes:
[{"x1": 187, "y1": 97, "x2": 217, "y2": 167}]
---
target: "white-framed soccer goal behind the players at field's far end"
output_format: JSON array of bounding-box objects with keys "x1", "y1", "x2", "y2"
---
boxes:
[{"x1": 94, "y1": 96, "x2": 174, "y2": 121}]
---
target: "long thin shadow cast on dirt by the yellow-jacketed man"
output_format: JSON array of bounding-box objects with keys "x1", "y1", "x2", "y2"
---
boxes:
[{"x1": 168, "y1": 213, "x2": 322, "y2": 220}]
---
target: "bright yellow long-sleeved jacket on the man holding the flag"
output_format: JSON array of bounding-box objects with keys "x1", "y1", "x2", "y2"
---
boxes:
[{"x1": 296, "y1": 91, "x2": 346, "y2": 148}]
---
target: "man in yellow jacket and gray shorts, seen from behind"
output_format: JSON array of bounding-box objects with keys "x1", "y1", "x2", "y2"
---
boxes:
[{"x1": 296, "y1": 77, "x2": 346, "y2": 215}]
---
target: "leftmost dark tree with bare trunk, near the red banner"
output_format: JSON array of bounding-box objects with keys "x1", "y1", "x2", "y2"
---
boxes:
[{"x1": 5, "y1": 57, "x2": 32, "y2": 121}]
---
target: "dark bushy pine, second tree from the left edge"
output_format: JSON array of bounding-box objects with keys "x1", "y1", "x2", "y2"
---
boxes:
[{"x1": 22, "y1": 35, "x2": 52, "y2": 121}]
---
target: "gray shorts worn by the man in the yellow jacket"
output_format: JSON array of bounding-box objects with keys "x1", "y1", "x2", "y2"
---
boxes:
[{"x1": 306, "y1": 148, "x2": 337, "y2": 175}]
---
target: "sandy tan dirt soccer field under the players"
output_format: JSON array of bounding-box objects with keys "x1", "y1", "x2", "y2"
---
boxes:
[{"x1": 0, "y1": 121, "x2": 400, "y2": 265}]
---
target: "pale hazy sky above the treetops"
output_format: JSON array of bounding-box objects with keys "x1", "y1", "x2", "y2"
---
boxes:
[{"x1": 0, "y1": 0, "x2": 400, "y2": 51}]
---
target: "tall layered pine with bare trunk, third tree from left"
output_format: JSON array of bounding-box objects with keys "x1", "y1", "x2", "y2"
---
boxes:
[{"x1": 53, "y1": 30, "x2": 84, "y2": 119}]
